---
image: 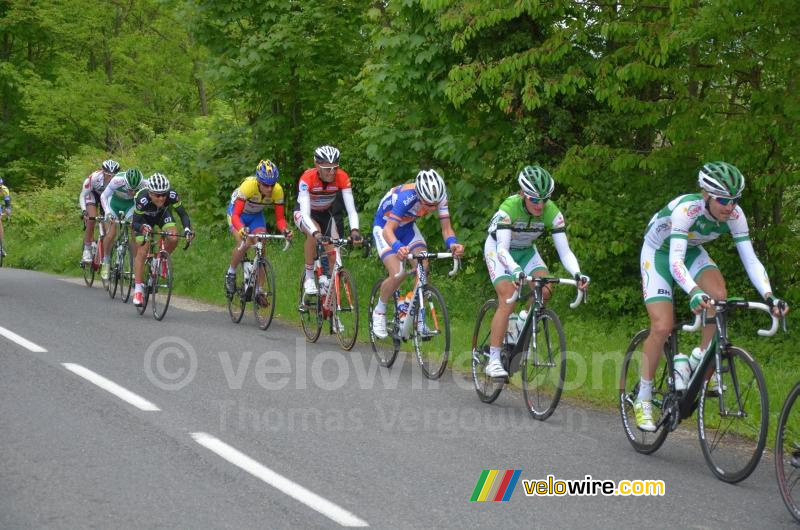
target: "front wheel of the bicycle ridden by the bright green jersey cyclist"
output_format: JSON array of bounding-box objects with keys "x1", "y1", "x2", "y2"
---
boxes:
[{"x1": 520, "y1": 309, "x2": 567, "y2": 420}]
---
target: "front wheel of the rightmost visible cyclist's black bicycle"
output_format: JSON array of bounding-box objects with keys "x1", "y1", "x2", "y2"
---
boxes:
[{"x1": 697, "y1": 346, "x2": 769, "y2": 483}]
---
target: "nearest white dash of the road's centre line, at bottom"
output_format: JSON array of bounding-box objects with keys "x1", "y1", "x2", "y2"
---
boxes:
[{"x1": 191, "y1": 432, "x2": 369, "y2": 526}]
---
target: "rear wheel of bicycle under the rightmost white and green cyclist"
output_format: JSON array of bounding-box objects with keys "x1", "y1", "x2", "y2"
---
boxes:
[{"x1": 619, "y1": 329, "x2": 672, "y2": 455}]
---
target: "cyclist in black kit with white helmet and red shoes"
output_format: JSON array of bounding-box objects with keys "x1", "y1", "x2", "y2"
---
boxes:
[{"x1": 131, "y1": 173, "x2": 194, "y2": 306}]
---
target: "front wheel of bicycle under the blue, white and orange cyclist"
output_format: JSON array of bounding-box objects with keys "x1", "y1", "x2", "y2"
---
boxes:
[{"x1": 412, "y1": 285, "x2": 450, "y2": 379}]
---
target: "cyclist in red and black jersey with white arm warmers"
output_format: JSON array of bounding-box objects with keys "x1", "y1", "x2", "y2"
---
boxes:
[{"x1": 294, "y1": 145, "x2": 362, "y2": 295}]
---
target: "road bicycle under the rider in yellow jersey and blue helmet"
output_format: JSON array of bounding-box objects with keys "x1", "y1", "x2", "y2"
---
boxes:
[{"x1": 227, "y1": 234, "x2": 290, "y2": 330}]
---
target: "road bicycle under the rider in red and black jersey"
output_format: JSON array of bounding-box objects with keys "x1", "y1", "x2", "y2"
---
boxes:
[{"x1": 298, "y1": 236, "x2": 358, "y2": 350}]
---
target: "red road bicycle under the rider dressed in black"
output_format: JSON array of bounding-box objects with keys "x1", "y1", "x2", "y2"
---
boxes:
[{"x1": 136, "y1": 231, "x2": 192, "y2": 320}]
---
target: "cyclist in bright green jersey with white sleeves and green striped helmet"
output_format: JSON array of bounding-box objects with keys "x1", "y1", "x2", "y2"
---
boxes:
[{"x1": 483, "y1": 166, "x2": 589, "y2": 377}]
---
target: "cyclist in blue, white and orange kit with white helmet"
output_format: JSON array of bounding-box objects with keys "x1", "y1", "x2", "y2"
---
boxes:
[{"x1": 372, "y1": 169, "x2": 464, "y2": 339}]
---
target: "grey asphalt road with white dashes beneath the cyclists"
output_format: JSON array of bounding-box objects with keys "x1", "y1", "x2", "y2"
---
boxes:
[{"x1": 0, "y1": 268, "x2": 796, "y2": 529}]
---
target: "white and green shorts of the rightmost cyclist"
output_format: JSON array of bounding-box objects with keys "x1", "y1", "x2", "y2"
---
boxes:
[{"x1": 640, "y1": 243, "x2": 717, "y2": 304}]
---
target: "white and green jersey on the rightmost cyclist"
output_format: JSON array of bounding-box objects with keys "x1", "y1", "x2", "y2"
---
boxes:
[{"x1": 644, "y1": 193, "x2": 750, "y2": 251}]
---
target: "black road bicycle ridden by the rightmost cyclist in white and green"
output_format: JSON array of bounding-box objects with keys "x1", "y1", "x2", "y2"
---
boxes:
[{"x1": 619, "y1": 299, "x2": 781, "y2": 483}]
